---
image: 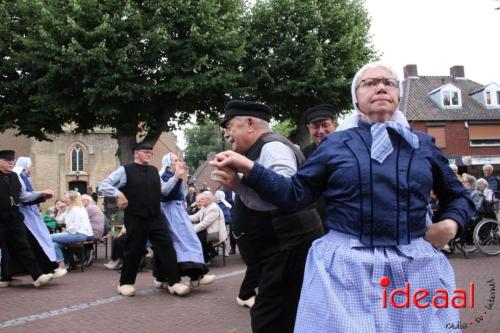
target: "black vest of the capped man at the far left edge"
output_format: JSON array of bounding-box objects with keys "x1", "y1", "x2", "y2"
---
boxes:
[{"x1": 0, "y1": 172, "x2": 21, "y2": 220}]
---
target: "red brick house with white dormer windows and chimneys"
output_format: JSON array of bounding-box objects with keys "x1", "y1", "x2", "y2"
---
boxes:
[{"x1": 400, "y1": 65, "x2": 500, "y2": 176}]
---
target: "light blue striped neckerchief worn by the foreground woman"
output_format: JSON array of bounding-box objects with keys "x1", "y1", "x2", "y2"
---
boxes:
[{"x1": 371, "y1": 121, "x2": 419, "y2": 163}]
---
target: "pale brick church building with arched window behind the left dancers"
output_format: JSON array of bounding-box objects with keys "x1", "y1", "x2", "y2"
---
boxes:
[{"x1": 0, "y1": 129, "x2": 182, "y2": 208}]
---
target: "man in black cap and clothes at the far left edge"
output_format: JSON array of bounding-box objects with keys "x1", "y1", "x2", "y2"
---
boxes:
[{"x1": 0, "y1": 150, "x2": 53, "y2": 287}]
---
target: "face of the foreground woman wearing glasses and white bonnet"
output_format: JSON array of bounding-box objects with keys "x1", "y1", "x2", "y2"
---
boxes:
[{"x1": 356, "y1": 67, "x2": 399, "y2": 122}]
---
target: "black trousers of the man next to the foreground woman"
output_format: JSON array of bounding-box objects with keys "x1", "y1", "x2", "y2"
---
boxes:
[{"x1": 250, "y1": 242, "x2": 311, "y2": 333}]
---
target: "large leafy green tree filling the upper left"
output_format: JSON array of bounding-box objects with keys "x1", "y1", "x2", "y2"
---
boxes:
[{"x1": 0, "y1": 0, "x2": 245, "y2": 163}]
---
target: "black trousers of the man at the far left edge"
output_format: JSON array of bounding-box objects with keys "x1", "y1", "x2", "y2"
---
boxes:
[{"x1": 0, "y1": 218, "x2": 43, "y2": 281}]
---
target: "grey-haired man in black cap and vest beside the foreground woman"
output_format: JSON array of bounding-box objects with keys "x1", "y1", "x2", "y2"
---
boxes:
[{"x1": 213, "y1": 100, "x2": 323, "y2": 332}]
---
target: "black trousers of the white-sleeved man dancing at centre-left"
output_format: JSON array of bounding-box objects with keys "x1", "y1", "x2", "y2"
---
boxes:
[{"x1": 120, "y1": 214, "x2": 181, "y2": 285}]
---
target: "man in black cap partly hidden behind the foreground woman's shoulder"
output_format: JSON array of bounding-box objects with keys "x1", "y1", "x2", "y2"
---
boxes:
[{"x1": 302, "y1": 104, "x2": 336, "y2": 158}]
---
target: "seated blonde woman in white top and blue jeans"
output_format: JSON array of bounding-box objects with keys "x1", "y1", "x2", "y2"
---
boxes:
[{"x1": 51, "y1": 191, "x2": 94, "y2": 274}]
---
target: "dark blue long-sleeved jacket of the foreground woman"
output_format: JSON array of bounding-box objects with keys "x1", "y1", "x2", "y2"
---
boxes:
[{"x1": 242, "y1": 122, "x2": 474, "y2": 245}]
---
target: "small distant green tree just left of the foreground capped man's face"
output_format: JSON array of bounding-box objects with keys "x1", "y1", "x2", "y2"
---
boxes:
[{"x1": 184, "y1": 121, "x2": 225, "y2": 174}]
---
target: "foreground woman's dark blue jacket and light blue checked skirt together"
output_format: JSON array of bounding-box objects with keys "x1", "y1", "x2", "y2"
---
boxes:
[{"x1": 242, "y1": 122, "x2": 474, "y2": 333}]
